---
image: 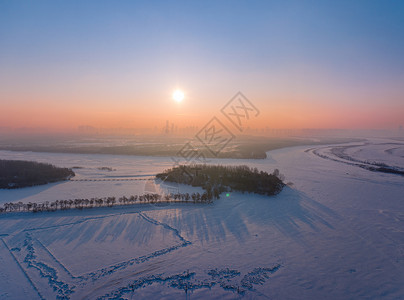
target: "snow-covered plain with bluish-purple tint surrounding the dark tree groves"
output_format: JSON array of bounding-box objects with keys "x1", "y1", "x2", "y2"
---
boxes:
[{"x1": 0, "y1": 139, "x2": 404, "y2": 299}]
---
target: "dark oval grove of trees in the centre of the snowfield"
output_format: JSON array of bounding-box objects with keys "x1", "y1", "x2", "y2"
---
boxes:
[{"x1": 156, "y1": 165, "x2": 285, "y2": 199}]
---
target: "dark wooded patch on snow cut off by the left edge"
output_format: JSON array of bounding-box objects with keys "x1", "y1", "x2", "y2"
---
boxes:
[{"x1": 0, "y1": 160, "x2": 75, "y2": 189}]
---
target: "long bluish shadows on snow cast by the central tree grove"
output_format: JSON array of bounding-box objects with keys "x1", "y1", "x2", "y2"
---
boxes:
[{"x1": 153, "y1": 187, "x2": 339, "y2": 243}]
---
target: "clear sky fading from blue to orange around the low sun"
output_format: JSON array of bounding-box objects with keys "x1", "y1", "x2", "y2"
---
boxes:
[{"x1": 0, "y1": 0, "x2": 404, "y2": 130}]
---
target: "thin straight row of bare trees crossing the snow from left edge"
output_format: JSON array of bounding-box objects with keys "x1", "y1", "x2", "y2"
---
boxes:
[{"x1": 0, "y1": 192, "x2": 212, "y2": 213}]
